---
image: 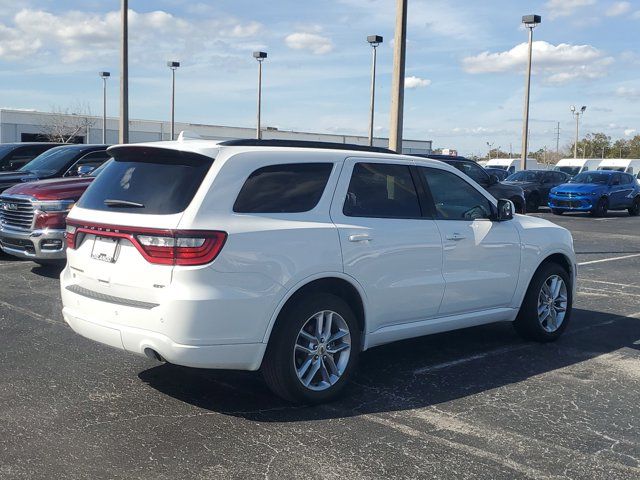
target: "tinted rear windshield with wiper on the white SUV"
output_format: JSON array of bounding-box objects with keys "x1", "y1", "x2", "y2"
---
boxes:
[{"x1": 78, "y1": 149, "x2": 213, "y2": 215}]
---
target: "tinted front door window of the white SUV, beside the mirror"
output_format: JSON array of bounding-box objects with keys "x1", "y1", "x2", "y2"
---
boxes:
[{"x1": 420, "y1": 167, "x2": 491, "y2": 220}]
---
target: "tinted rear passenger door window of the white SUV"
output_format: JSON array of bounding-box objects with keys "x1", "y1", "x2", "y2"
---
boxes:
[{"x1": 342, "y1": 163, "x2": 421, "y2": 218}]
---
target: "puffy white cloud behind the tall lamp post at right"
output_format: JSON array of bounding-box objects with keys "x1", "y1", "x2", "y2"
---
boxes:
[{"x1": 462, "y1": 41, "x2": 614, "y2": 83}]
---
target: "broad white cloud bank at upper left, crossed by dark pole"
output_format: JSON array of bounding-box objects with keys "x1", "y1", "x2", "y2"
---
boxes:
[{"x1": 0, "y1": 8, "x2": 262, "y2": 64}]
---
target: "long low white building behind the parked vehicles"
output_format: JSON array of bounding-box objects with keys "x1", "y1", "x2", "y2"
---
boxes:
[{"x1": 0, "y1": 108, "x2": 432, "y2": 153}]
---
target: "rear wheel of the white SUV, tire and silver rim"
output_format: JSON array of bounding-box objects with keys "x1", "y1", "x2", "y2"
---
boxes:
[{"x1": 262, "y1": 293, "x2": 360, "y2": 404}]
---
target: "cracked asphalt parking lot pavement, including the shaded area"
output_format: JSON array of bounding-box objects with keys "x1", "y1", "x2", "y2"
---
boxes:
[{"x1": 0, "y1": 212, "x2": 640, "y2": 480}]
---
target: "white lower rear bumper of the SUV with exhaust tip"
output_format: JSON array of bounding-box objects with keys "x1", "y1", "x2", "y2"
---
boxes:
[{"x1": 62, "y1": 306, "x2": 267, "y2": 370}]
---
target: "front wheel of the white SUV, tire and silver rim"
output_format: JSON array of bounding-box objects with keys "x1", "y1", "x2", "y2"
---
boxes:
[{"x1": 514, "y1": 263, "x2": 573, "y2": 342}]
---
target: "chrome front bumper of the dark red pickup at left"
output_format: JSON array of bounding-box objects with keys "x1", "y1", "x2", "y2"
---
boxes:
[{"x1": 0, "y1": 227, "x2": 66, "y2": 260}]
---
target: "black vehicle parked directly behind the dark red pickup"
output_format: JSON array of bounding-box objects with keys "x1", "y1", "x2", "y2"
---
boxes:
[{"x1": 0, "y1": 144, "x2": 111, "y2": 192}]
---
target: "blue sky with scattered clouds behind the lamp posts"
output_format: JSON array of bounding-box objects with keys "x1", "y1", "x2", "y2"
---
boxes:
[{"x1": 0, "y1": 0, "x2": 640, "y2": 156}]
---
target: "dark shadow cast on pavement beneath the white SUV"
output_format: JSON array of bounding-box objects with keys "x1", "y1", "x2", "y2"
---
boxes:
[{"x1": 138, "y1": 309, "x2": 640, "y2": 422}]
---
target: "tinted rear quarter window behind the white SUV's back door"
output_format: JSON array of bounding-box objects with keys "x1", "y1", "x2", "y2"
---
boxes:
[{"x1": 233, "y1": 163, "x2": 333, "y2": 213}]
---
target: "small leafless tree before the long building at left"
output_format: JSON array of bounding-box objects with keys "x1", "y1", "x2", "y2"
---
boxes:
[{"x1": 41, "y1": 103, "x2": 96, "y2": 143}]
